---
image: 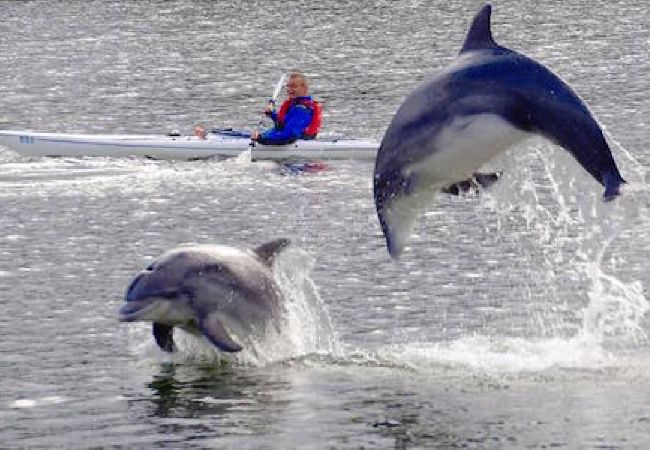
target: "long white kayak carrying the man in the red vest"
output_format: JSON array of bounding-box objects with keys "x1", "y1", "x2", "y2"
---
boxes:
[{"x1": 0, "y1": 130, "x2": 379, "y2": 161}]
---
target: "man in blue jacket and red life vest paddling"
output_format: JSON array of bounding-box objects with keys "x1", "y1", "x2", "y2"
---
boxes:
[{"x1": 251, "y1": 72, "x2": 321, "y2": 145}]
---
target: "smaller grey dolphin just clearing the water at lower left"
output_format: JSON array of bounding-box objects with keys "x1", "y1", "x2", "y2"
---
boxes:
[{"x1": 119, "y1": 239, "x2": 289, "y2": 352}]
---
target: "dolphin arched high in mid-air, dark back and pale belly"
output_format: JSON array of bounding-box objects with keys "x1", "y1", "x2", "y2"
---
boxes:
[{"x1": 374, "y1": 5, "x2": 625, "y2": 258}]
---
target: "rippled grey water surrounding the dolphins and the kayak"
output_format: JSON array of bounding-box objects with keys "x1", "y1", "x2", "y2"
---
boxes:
[{"x1": 0, "y1": 0, "x2": 650, "y2": 448}]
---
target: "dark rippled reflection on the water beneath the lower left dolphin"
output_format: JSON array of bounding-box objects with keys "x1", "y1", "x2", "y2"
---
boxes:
[{"x1": 128, "y1": 362, "x2": 290, "y2": 445}]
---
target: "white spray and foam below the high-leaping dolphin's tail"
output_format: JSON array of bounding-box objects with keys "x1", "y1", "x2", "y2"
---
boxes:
[{"x1": 377, "y1": 139, "x2": 650, "y2": 373}]
